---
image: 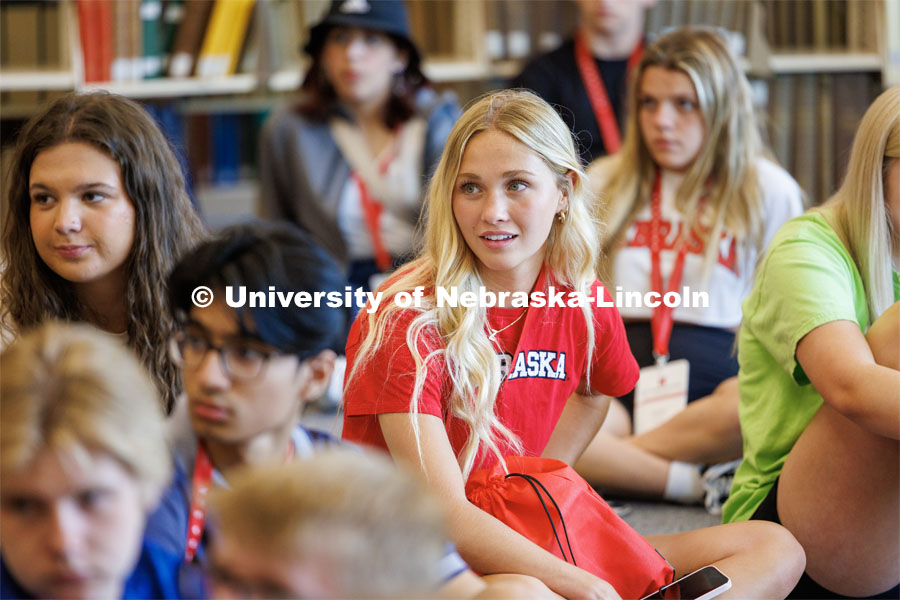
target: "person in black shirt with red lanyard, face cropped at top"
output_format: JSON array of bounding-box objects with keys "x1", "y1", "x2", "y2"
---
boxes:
[{"x1": 510, "y1": 0, "x2": 653, "y2": 164}]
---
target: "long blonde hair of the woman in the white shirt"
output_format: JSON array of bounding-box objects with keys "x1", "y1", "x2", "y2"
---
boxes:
[{"x1": 598, "y1": 27, "x2": 771, "y2": 282}]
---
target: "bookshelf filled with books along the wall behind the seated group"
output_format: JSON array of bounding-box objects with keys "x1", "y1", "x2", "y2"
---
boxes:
[{"x1": 0, "y1": 0, "x2": 900, "y2": 223}]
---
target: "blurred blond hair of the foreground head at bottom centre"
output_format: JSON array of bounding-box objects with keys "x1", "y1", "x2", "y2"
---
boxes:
[{"x1": 210, "y1": 450, "x2": 447, "y2": 598}]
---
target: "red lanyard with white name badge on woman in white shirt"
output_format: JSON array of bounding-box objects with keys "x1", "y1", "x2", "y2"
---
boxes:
[{"x1": 634, "y1": 172, "x2": 704, "y2": 434}]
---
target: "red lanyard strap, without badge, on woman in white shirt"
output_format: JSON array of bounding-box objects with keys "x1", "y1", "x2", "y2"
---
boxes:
[{"x1": 650, "y1": 171, "x2": 705, "y2": 361}]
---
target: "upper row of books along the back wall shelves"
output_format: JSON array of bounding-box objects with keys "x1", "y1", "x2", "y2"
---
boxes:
[{"x1": 0, "y1": 0, "x2": 885, "y2": 89}]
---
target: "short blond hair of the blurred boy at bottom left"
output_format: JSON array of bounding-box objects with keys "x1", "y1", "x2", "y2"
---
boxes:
[{"x1": 0, "y1": 321, "x2": 171, "y2": 508}]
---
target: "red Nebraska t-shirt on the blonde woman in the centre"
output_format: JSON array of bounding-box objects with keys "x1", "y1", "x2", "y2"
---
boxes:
[{"x1": 343, "y1": 276, "x2": 639, "y2": 468}]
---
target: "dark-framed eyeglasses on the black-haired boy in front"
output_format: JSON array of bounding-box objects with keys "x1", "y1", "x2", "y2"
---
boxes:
[{"x1": 169, "y1": 328, "x2": 283, "y2": 380}]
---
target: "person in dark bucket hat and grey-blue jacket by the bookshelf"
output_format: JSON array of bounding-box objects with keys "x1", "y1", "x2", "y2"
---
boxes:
[{"x1": 260, "y1": 0, "x2": 460, "y2": 289}]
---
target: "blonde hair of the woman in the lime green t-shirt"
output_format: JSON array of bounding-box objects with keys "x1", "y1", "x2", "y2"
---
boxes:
[{"x1": 816, "y1": 85, "x2": 900, "y2": 321}]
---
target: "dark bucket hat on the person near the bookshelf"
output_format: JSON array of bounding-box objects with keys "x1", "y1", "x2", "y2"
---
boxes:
[{"x1": 304, "y1": 0, "x2": 420, "y2": 65}]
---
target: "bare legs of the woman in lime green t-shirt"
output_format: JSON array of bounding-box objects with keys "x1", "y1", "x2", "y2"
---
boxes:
[{"x1": 778, "y1": 303, "x2": 900, "y2": 596}]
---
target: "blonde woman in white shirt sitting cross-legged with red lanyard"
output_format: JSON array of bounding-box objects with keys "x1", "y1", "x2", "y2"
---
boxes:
[{"x1": 576, "y1": 28, "x2": 802, "y2": 506}]
